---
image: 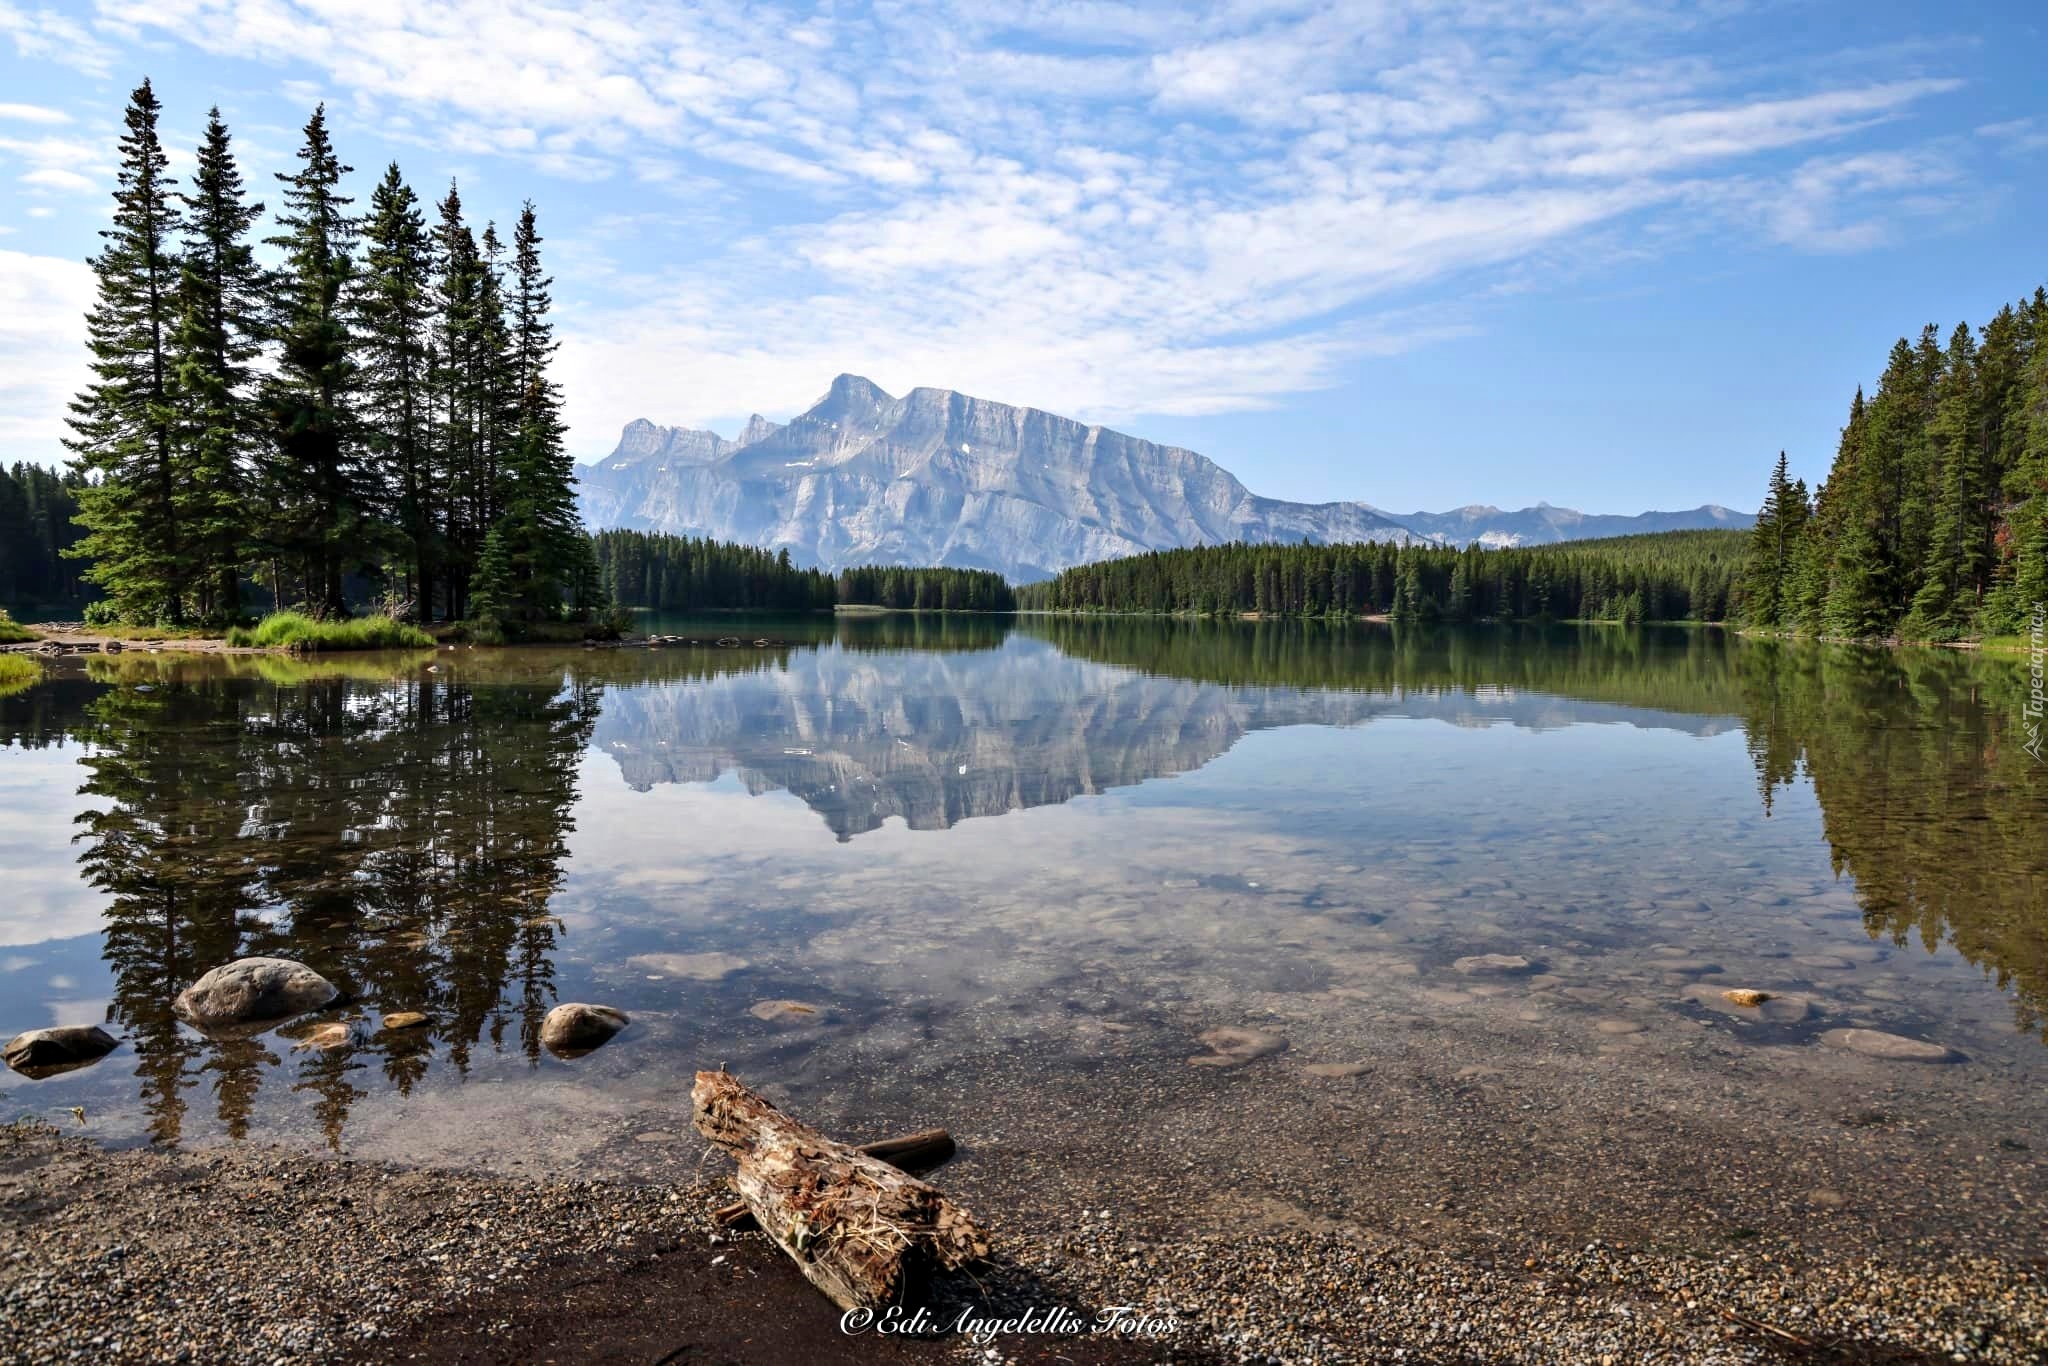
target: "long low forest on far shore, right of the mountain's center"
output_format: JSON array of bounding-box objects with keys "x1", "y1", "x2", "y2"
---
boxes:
[{"x1": 1018, "y1": 530, "x2": 1745, "y2": 623}]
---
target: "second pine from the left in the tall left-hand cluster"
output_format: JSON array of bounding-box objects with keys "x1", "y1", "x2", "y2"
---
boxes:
[{"x1": 174, "y1": 109, "x2": 262, "y2": 621}]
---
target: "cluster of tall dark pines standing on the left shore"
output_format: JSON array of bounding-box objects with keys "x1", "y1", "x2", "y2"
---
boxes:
[{"x1": 49, "y1": 80, "x2": 600, "y2": 627}]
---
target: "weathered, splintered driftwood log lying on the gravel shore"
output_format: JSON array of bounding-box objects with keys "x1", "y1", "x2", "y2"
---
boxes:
[{"x1": 690, "y1": 1071, "x2": 989, "y2": 1309}]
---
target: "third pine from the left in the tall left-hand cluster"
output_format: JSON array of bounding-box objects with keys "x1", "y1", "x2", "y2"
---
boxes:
[{"x1": 264, "y1": 106, "x2": 371, "y2": 616}]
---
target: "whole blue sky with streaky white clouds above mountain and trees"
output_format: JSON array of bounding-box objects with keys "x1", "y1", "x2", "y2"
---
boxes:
[{"x1": 0, "y1": 0, "x2": 2048, "y2": 512}]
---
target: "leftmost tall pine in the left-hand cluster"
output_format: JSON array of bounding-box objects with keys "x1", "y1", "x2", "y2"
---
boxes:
[{"x1": 66, "y1": 80, "x2": 193, "y2": 625}]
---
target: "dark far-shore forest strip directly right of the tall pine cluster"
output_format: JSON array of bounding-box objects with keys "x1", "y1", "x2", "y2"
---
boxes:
[{"x1": 590, "y1": 530, "x2": 1016, "y2": 612}]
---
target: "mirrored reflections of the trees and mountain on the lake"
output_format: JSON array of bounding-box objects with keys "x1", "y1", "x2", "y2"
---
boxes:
[{"x1": 0, "y1": 616, "x2": 2048, "y2": 1147}]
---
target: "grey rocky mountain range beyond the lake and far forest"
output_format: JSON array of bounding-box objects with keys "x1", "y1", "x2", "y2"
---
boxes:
[{"x1": 580, "y1": 375, "x2": 1753, "y2": 584}]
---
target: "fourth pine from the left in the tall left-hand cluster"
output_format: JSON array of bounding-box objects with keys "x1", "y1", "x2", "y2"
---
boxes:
[{"x1": 358, "y1": 162, "x2": 440, "y2": 621}]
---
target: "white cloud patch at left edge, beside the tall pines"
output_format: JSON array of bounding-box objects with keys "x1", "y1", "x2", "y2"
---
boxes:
[{"x1": 0, "y1": 250, "x2": 92, "y2": 465}]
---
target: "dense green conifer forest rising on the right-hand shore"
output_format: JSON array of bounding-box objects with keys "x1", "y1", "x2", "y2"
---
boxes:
[{"x1": 1743, "y1": 289, "x2": 2048, "y2": 641}]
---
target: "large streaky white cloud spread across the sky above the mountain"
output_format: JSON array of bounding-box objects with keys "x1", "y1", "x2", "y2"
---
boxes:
[{"x1": 19, "y1": 0, "x2": 1982, "y2": 453}]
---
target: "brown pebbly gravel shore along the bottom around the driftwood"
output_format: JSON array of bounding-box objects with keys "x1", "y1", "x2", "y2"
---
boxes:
[{"x1": 0, "y1": 1122, "x2": 2048, "y2": 1362}]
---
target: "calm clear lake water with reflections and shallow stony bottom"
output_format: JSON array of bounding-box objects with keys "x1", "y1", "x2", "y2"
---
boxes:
[{"x1": 0, "y1": 616, "x2": 2048, "y2": 1245}]
